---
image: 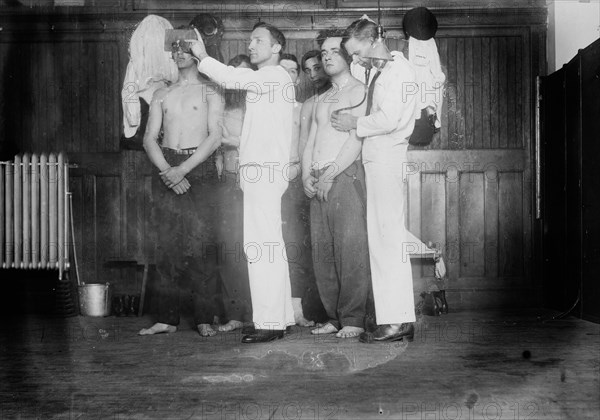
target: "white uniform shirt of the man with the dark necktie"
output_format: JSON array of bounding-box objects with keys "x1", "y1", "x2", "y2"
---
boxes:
[{"x1": 356, "y1": 51, "x2": 420, "y2": 161}]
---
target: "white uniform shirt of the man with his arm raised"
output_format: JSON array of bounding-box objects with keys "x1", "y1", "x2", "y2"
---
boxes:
[{"x1": 198, "y1": 57, "x2": 296, "y2": 171}]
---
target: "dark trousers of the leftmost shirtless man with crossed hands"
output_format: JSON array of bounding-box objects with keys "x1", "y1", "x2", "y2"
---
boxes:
[{"x1": 152, "y1": 153, "x2": 223, "y2": 325}]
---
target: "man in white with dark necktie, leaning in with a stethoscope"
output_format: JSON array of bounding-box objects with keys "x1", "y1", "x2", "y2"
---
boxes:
[{"x1": 331, "y1": 19, "x2": 418, "y2": 343}]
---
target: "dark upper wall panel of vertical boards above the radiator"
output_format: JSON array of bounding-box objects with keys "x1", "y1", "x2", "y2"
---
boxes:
[{"x1": 0, "y1": 39, "x2": 124, "y2": 153}]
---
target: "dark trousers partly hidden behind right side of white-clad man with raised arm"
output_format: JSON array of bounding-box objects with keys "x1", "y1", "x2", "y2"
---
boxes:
[{"x1": 281, "y1": 176, "x2": 325, "y2": 321}]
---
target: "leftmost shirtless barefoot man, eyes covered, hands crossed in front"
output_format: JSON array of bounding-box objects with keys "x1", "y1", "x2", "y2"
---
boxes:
[{"x1": 139, "y1": 40, "x2": 223, "y2": 336}]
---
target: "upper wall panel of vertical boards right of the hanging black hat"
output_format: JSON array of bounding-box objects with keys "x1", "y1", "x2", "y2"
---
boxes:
[{"x1": 432, "y1": 32, "x2": 529, "y2": 149}]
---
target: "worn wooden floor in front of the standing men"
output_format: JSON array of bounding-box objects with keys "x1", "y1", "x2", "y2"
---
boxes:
[{"x1": 0, "y1": 310, "x2": 600, "y2": 420}]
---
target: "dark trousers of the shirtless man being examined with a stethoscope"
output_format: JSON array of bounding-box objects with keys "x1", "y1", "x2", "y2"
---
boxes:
[{"x1": 310, "y1": 162, "x2": 371, "y2": 329}]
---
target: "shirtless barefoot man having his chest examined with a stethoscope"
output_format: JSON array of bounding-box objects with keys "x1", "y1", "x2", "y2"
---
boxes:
[{"x1": 302, "y1": 30, "x2": 370, "y2": 338}]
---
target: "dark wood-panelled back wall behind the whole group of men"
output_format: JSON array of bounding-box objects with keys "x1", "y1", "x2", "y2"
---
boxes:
[{"x1": 0, "y1": 2, "x2": 545, "y2": 306}]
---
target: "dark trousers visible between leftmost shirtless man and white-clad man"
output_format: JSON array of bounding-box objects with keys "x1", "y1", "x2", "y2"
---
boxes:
[{"x1": 216, "y1": 171, "x2": 252, "y2": 322}]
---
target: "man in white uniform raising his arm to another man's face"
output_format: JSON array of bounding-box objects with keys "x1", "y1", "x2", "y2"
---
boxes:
[{"x1": 192, "y1": 23, "x2": 294, "y2": 343}]
